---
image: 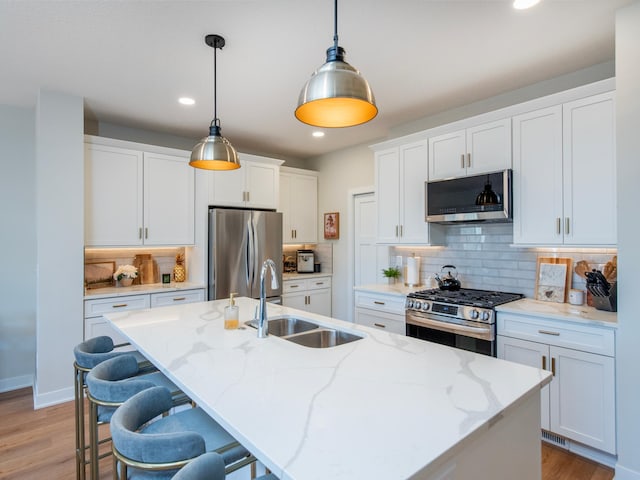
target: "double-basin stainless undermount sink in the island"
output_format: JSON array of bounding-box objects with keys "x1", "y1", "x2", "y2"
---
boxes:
[{"x1": 245, "y1": 316, "x2": 362, "y2": 348}]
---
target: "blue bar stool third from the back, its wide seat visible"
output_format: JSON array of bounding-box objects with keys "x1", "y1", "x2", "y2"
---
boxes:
[{"x1": 111, "y1": 387, "x2": 256, "y2": 480}]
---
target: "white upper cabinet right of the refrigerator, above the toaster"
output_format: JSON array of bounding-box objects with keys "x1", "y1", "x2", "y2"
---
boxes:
[{"x1": 278, "y1": 167, "x2": 318, "y2": 243}]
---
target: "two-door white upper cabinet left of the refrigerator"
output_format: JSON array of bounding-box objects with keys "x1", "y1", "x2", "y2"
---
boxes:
[{"x1": 85, "y1": 140, "x2": 195, "y2": 247}]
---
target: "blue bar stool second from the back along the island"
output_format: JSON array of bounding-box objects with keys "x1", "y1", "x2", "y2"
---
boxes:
[{"x1": 86, "y1": 354, "x2": 189, "y2": 480}]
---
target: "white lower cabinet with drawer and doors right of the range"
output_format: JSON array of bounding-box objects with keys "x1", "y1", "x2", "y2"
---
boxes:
[{"x1": 498, "y1": 312, "x2": 616, "y2": 454}]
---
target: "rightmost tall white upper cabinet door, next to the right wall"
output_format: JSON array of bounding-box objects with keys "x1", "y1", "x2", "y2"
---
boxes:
[{"x1": 563, "y1": 93, "x2": 617, "y2": 245}]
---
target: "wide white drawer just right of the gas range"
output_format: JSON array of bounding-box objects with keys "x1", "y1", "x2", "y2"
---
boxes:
[{"x1": 497, "y1": 312, "x2": 615, "y2": 357}]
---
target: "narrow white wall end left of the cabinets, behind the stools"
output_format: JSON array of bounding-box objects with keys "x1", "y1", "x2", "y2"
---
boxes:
[{"x1": 34, "y1": 91, "x2": 84, "y2": 408}]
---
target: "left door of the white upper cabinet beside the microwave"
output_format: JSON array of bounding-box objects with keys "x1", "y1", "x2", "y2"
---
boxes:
[{"x1": 375, "y1": 148, "x2": 400, "y2": 244}]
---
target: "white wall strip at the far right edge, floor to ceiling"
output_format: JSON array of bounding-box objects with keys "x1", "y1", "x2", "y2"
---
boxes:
[{"x1": 615, "y1": 1, "x2": 640, "y2": 480}]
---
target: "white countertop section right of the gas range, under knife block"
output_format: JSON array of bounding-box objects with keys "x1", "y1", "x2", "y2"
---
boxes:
[{"x1": 496, "y1": 298, "x2": 618, "y2": 328}]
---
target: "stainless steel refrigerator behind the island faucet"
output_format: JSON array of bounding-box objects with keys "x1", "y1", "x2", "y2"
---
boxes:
[{"x1": 209, "y1": 208, "x2": 282, "y2": 303}]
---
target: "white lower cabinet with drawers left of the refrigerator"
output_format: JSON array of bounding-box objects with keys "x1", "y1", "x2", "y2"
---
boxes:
[{"x1": 84, "y1": 288, "x2": 204, "y2": 344}]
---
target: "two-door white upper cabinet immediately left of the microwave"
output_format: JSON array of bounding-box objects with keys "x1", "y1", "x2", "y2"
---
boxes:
[{"x1": 375, "y1": 141, "x2": 429, "y2": 245}]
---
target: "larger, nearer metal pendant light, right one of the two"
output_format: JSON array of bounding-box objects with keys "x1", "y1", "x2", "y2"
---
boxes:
[{"x1": 295, "y1": 0, "x2": 378, "y2": 127}]
